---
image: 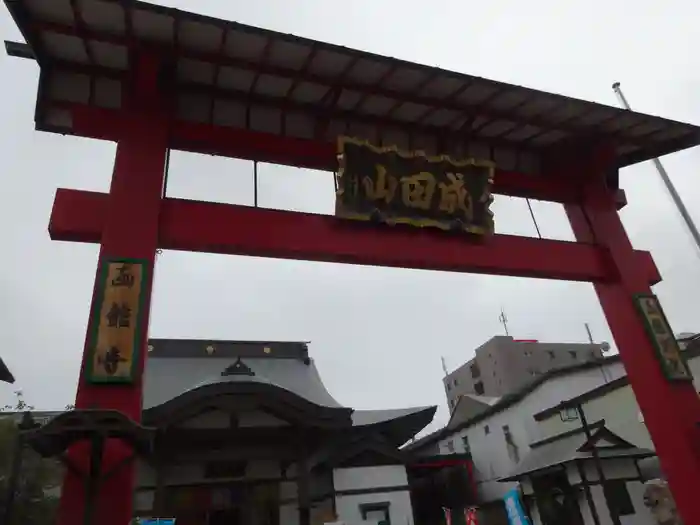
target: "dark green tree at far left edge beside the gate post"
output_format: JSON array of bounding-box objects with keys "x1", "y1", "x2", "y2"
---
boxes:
[{"x1": 0, "y1": 392, "x2": 62, "y2": 525}]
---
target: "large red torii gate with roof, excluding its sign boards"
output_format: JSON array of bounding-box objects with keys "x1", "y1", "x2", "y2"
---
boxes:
[{"x1": 5, "y1": 0, "x2": 700, "y2": 525}]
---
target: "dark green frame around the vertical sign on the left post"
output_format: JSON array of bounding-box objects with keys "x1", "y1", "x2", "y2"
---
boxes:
[{"x1": 85, "y1": 257, "x2": 148, "y2": 385}]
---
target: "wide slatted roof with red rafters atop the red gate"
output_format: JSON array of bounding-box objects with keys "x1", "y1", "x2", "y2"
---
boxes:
[{"x1": 5, "y1": 0, "x2": 700, "y2": 173}]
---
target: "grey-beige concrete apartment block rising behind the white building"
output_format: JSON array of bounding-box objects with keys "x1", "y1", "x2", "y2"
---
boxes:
[{"x1": 443, "y1": 336, "x2": 605, "y2": 412}]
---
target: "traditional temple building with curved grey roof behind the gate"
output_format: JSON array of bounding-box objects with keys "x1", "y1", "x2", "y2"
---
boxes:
[{"x1": 135, "y1": 339, "x2": 469, "y2": 525}]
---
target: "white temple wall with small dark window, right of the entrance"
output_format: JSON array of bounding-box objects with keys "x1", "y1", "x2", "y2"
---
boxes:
[{"x1": 333, "y1": 465, "x2": 413, "y2": 525}]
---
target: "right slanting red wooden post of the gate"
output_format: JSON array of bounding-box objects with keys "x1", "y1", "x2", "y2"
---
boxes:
[{"x1": 565, "y1": 142, "x2": 700, "y2": 524}]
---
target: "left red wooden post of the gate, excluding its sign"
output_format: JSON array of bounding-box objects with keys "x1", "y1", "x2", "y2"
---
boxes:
[{"x1": 57, "y1": 54, "x2": 168, "y2": 525}]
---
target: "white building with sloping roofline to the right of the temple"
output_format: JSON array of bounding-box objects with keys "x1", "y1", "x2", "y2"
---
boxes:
[{"x1": 408, "y1": 336, "x2": 700, "y2": 525}]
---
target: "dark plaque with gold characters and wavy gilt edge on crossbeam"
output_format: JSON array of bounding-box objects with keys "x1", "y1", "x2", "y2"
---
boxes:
[{"x1": 336, "y1": 137, "x2": 495, "y2": 235}]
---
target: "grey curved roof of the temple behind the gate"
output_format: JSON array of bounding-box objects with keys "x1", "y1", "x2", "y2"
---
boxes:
[{"x1": 143, "y1": 339, "x2": 436, "y2": 443}]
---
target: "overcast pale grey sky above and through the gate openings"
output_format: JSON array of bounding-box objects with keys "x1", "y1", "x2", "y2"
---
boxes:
[{"x1": 0, "y1": 0, "x2": 700, "y2": 430}]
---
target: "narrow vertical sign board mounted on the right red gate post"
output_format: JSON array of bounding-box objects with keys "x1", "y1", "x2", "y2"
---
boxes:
[{"x1": 634, "y1": 294, "x2": 693, "y2": 382}]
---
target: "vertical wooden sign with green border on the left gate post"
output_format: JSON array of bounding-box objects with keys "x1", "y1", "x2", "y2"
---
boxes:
[{"x1": 86, "y1": 259, "x2": 147, "y2": 384}]
